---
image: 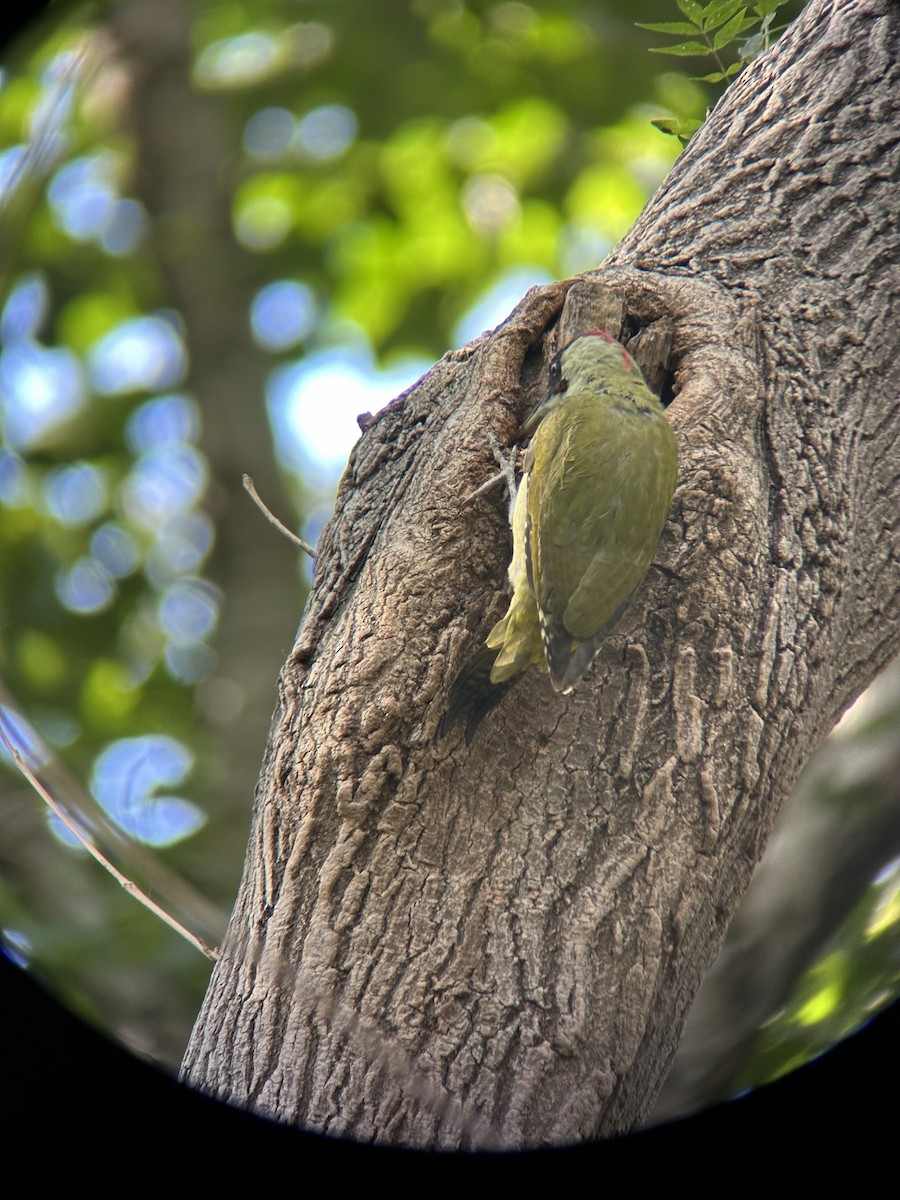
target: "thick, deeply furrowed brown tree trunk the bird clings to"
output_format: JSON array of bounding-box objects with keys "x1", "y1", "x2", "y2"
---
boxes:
[{"x1": 185, "y1": 0, "x2": 900, "y2": 1148}]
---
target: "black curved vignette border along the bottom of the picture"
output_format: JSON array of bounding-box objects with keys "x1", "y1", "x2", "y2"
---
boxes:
[{"x1": 0, "y1": 955, "x2": 900, "y2": 1180}]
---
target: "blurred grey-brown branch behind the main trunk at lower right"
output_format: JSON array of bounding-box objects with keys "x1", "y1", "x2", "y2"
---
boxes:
[{"x1": 650, "y1": 659, "x2": 900, "y2": 1124}]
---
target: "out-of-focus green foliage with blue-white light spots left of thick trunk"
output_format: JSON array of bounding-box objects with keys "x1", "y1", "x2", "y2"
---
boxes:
[{"x1": 0, "y1": 0, "x2": 897, "y2": 1123}]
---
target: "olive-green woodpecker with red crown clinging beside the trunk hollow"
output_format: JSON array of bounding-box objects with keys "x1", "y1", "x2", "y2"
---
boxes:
[{"x1": 439, "y1": 332, "x2": 678, "y2": 742}]
